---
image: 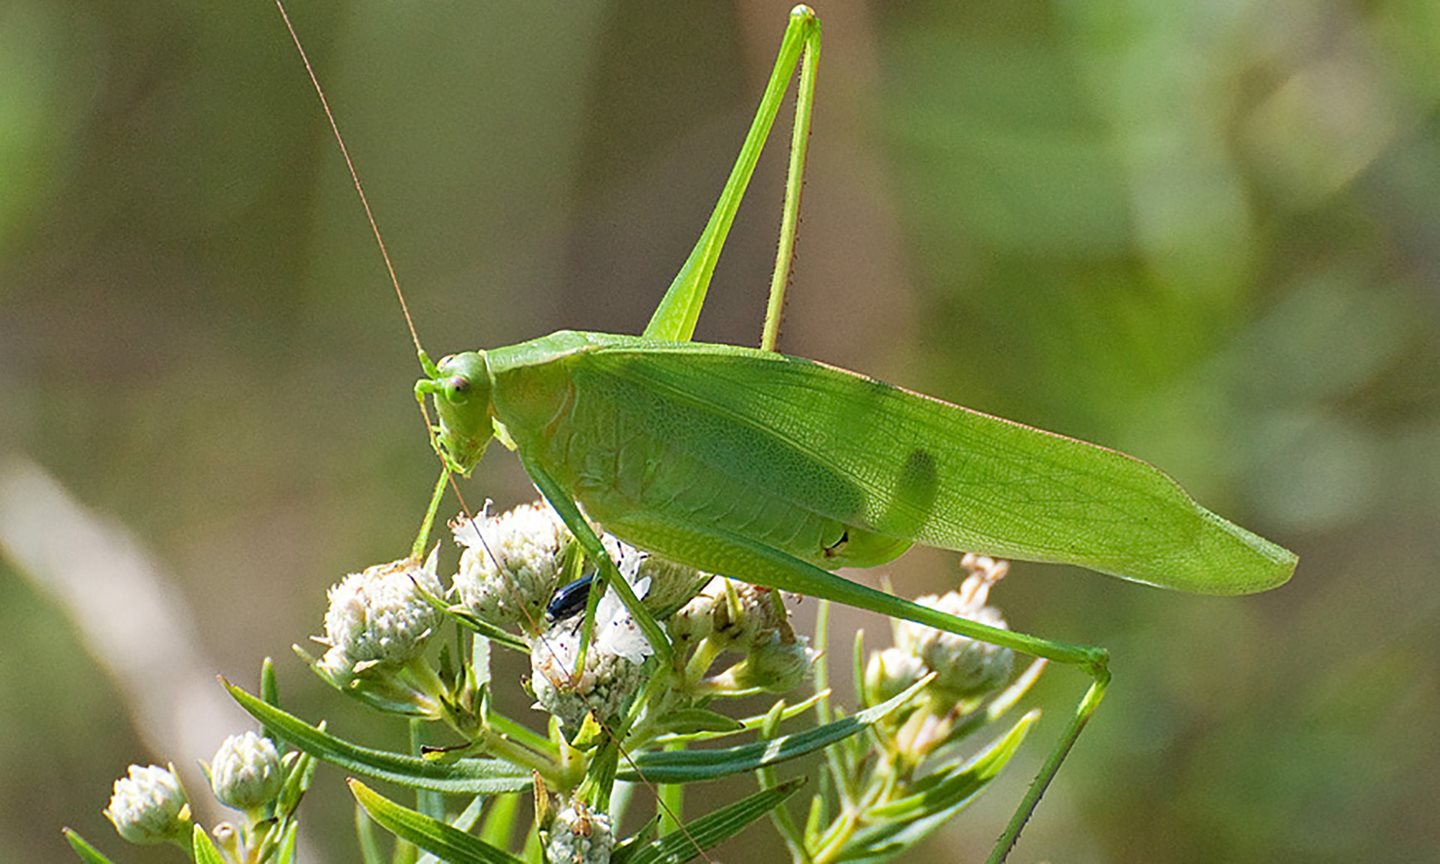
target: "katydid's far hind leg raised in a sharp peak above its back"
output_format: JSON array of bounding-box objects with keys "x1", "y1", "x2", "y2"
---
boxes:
[{"x1": 644, "y1": 6, "x2": 819, "y2": 341}]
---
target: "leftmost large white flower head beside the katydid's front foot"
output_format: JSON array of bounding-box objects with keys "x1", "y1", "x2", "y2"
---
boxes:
[{"x1": 321, "y1": 557, "x2": 441, "y2": 680}]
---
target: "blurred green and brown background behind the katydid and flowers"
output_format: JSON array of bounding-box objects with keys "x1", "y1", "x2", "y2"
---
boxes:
[{"x1": 0, "y1": 0, "x2": 1440, "y2": 863}]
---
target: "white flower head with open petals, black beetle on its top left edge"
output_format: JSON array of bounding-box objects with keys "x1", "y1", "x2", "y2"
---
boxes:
[{"x1": 530, "y1": 554, "x2": 654, "y2": 729}]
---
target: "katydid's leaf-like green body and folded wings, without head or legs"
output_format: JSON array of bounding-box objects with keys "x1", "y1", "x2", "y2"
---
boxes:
[{"x1": 472, "y1": 331, "x2": 1295, "y2": 593}]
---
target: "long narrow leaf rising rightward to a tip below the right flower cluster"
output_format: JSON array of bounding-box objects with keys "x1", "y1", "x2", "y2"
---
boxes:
[{"x1": 619, "y1": 674, "x2": 935, "y2": 783}]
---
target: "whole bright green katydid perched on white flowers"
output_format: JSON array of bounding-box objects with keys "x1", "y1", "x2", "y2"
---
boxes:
[{"x1": 277, "y1": 6, "x2": 1296, "y2": 861}]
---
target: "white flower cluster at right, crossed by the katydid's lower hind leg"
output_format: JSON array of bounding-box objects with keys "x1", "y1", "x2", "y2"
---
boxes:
[{"x1": 865, "y1": 553, "x2": 1015, "y2": 703}]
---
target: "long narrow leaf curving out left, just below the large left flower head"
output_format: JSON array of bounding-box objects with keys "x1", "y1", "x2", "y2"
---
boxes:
[{"x1": 222, "y1": 680, "x2": 530, "y2": 795}]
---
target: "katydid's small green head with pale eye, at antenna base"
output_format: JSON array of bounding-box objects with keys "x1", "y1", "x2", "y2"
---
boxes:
[{"x1": 415, "y1": 351, "x2": 495, "y2": 477}]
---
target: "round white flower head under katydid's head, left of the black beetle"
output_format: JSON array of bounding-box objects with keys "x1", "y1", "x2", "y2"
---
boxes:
[{"x1": 451, "y1": 501, "x2": 570, "y2": 632}]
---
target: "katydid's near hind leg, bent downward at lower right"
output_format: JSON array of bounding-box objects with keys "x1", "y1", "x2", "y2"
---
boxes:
[{"x1": 606, "y1": 514, "x2": 1110, "y2": 864}]
